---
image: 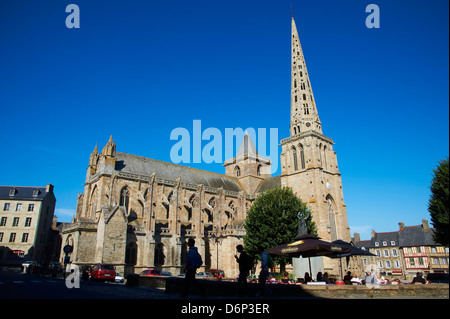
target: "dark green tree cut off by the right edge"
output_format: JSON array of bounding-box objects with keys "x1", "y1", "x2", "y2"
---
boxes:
[{"x1": 428, "y1": 157, "x2": 449, "y2": 246}]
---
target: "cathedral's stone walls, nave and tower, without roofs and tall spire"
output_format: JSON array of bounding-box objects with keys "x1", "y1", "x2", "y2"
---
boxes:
[{"x1": 62, "y1": 134, "x2": 350, "y2": 277}]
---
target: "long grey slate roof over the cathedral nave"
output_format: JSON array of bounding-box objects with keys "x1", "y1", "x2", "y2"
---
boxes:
[{"x1": 115, "y1": 152, "x2": 242, "y2": 192}]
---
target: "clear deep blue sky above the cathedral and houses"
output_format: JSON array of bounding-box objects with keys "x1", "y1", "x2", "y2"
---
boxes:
[{"x1": 0, "y1": 0, "x2": 449, "y2": 239}]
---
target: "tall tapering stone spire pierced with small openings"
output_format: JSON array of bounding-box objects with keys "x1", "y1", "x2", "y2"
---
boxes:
[{"x1": 291, "y1": 17, "x2": 322, "y2": 136}]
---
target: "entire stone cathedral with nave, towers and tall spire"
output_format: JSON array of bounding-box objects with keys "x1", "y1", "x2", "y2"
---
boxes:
[{"x1": 61, "y1": 18, "x2": 350, "y2": 278}]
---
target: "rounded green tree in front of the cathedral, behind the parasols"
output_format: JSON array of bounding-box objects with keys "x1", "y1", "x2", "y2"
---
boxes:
[{"x1": 244, "y1": 187, "x2": 317, "y2": 271}]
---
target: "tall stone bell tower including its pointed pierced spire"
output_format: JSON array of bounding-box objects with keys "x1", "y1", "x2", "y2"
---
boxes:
[{"x1": 280, "y1": 18, "x2": 351, "y2": 254}]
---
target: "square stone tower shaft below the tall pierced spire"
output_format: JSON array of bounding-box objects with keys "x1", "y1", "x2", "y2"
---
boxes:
[{"x1": 280, "y1": 132, "x2": 351, "y2": 274}]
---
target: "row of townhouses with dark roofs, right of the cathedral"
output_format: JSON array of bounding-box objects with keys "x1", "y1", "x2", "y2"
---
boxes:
[{"x1": 353, "y1": 219, "x2": 449, "y2": 280}]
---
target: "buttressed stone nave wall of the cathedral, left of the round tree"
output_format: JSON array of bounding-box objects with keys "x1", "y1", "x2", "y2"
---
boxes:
[{"x1": 65, "y1": 165, "x2": 252, "y2": 276}]
